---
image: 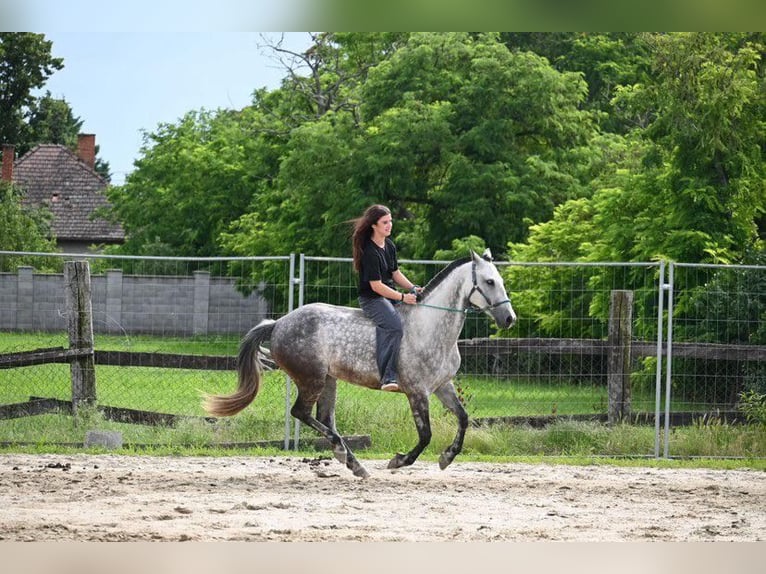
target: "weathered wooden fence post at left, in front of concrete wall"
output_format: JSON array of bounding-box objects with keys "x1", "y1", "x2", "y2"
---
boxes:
[{"x1": 64, "y1": 261, "x2": 96, "y2": 414}]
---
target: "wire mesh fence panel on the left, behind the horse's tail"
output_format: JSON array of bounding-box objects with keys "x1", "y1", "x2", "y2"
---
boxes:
[{"x1": 0, "y1": 255, "x2": 292, "y2": 450}]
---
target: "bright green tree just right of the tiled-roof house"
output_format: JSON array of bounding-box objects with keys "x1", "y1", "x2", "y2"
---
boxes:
[{"x1": 107, "y1": 110, "x2": 262, "y2": 256}]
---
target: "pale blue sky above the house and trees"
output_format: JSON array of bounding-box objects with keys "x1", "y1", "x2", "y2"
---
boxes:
[{"x1": 35, "y1": 30, "x2": 310, "y2": 185}]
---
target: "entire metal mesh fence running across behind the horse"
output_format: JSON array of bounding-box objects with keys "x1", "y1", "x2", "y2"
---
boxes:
[{"x1": 0, "y1": 252, "x2": 766, "y2": 456}]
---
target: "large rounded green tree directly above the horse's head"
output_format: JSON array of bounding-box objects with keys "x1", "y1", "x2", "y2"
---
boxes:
[{"x1": 362, "y1": 34, "x2": 595, "y2": 256}]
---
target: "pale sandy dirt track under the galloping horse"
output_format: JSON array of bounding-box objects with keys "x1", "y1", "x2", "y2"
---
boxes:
[{"x1": 0, "y1": 455, "x2": 766, "y2": 541}]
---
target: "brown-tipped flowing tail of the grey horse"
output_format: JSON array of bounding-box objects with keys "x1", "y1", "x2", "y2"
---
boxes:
[{"x1": 202, "y1": 320, "x2": 274, "y2": 417}]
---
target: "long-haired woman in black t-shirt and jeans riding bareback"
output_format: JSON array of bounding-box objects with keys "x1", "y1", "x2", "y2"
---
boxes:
[{"x1": 351, "y1": 205, "x2": 422, "y2": 391}]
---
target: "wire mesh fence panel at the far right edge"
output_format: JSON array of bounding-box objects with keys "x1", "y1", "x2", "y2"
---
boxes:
[{"x1": 664, "y1": 263, "x2": 766, "y2": 456}]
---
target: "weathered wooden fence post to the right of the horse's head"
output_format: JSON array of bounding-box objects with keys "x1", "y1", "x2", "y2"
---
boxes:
[{"x1": 607, "y1": 290, "x2": 633, "y2": 424}]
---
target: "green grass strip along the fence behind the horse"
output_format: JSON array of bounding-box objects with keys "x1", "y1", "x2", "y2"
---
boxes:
[{"x1": 0, "y1": 333, "x2": 766, "y2": 467}]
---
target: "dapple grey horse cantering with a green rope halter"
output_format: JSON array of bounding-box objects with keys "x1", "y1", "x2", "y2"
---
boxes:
[{"x1": 203, "y1": 249, "x2": 516, "y2": 478}]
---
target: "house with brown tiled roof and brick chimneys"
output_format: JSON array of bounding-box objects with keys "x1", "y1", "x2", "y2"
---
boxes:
[{"x1": 2, "y1": 134, "x2": 125, "y2": 253}]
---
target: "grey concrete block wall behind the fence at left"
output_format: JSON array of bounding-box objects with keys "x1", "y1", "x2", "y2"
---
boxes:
[{"x1": 0, "y1": 267, "x2": 268, "y2": 335}]
